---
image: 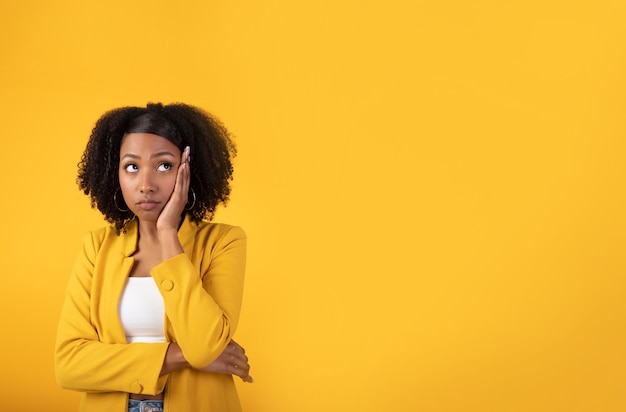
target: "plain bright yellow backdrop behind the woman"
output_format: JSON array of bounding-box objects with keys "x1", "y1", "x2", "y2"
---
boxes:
[{"x1": 0, "y1": 0, "x2": 626, "y2": 412}]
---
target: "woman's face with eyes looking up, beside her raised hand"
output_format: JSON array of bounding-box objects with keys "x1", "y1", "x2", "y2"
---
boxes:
[{"x1": 119, "y1": 133, "x2": 181, "y2": 222}]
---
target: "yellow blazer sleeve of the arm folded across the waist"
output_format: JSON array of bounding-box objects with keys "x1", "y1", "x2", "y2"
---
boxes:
[{"x1": 54, "y1": 234, "x2": 169, "y2": 394}]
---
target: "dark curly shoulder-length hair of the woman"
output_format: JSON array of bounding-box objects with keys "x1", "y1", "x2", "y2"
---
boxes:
[{"x1": 76, "y1": 103, "x2": 237, "y2": 233}]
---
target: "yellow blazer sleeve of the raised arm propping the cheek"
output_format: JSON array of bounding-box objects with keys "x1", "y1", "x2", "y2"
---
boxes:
[{"x1": 151, "y1": 225, "x2": 246, "y2": 367}]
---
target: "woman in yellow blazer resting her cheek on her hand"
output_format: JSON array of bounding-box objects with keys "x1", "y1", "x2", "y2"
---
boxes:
[{"x1": 55, "y1": 104, "x2": 252, "y2": 412}]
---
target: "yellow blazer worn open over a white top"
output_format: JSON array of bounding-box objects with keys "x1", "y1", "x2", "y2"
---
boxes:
[{"x1": 55, "y1": 218, "x2": 246, "y2": 412}]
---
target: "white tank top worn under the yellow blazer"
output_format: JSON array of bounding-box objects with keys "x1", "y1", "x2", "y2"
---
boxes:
[{"x1": 119, "y1": 276, "x2": 165, "y2": 343}]
